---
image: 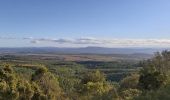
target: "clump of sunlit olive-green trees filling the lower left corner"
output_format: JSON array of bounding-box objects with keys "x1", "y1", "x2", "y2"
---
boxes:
[{"x1": 0, "y1": 66, "x2": 65, "y2": 100}]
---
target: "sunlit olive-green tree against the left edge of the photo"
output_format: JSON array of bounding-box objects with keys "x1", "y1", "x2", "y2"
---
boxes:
[{"x1": 0, "y1": 65, "x2": 19, "y2": 100}]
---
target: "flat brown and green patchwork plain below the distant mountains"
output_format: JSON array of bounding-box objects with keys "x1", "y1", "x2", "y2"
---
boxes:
[{"x1": 0, "y1": 53, "x2": 150, "y2": 81}]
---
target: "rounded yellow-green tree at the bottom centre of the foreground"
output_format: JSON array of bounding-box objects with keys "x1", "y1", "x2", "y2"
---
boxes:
[{"x1": 80, "y1": 70, "x2": 113, "y2": 100}]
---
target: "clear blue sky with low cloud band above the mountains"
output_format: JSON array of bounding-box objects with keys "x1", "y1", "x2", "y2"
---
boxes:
[{"x1": 0, "y1": 0, "x2": 170, "y2": 47}]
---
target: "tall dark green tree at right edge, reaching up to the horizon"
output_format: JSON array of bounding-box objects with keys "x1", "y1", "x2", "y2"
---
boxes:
[{"x1": 139, "y1": 50, "x2": 170, "y2": 91}]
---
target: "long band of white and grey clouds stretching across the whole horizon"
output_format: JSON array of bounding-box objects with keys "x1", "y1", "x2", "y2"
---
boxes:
[{"x1": 0, "y1": 37, "x2": 170, "y2": 47}]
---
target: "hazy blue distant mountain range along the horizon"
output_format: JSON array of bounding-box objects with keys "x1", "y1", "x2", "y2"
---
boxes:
[{"x1": 0, "y1": 47, "x2": 170, "y2": 54}]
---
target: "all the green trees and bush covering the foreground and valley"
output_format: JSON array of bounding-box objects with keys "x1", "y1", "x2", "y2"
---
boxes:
[{"x1": 0, "y1": 51, "x2": 170, "y2": 100}]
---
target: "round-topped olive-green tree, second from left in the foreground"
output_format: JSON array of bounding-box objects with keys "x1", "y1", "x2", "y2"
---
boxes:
[{"x1": 32, "y1": 67, "x2": 63, "y2": 100}]
